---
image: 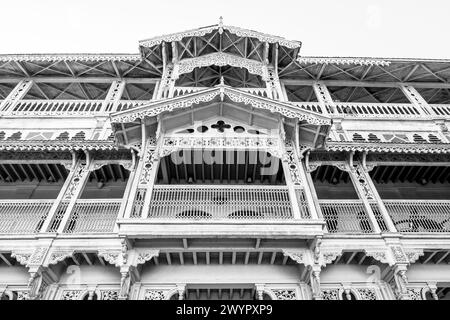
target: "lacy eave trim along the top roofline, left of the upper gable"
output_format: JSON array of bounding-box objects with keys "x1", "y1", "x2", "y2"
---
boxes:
[{"x1": 0, "y1": 53, "x2": 142, "y2": 62}]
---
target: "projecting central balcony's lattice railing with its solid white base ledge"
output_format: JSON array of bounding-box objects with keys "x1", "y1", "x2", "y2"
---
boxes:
[{"x1": 119, "y1": 185, "x2": 323, "y2": 237}]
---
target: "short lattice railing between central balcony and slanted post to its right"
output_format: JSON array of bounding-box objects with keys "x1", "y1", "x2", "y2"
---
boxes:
[{"x1": 319, "y1": 200, "x2": 373, "y2": 233}]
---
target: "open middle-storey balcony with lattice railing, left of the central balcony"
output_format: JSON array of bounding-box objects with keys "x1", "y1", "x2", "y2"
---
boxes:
[{"x1": 0, "y1": 163, "x2": 128, "y2": 235}]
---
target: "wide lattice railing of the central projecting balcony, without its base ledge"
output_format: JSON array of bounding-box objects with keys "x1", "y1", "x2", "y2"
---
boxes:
[{"x1": 141, "y1": 185, "x2": 296, "y2": 220}]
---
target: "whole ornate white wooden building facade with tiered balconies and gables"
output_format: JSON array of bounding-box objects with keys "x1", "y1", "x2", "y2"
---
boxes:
[{"x1": 0, "y1": 21, "x2": 450, "y2": 300}]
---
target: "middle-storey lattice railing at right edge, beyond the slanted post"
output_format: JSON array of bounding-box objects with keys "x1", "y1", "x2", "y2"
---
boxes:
[{"x1": 383, "y1": 200, "x2": 450, "y2": 233}]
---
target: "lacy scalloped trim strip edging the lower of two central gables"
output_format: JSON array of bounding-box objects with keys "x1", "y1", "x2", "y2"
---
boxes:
[{"x1": 110, "y1": 85, "x2": 331, "y2": 125}]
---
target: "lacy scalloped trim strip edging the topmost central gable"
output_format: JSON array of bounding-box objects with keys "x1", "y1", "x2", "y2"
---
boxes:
[{"x1": 139, "y1": 23, "x2": 302, "y2": 49}]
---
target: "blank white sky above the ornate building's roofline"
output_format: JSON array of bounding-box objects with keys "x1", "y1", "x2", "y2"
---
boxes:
[{"x1": 0, "y1": 0, "x2": 450, "y2": 58}]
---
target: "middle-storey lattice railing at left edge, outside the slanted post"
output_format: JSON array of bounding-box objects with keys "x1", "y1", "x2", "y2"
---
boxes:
[{"x1": 0, "y1": 199, "x2": 54, "y2": 234}]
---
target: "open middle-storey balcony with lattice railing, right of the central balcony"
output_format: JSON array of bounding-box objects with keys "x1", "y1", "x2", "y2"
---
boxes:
[{"x1": 312, "y1": 165, "x2": 450, "y2": 234}]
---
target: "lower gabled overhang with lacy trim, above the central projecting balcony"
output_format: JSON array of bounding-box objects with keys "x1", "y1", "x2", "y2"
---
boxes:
[{"x1": 110, "y1": 84, "x2": 331, "y2": 147}]
